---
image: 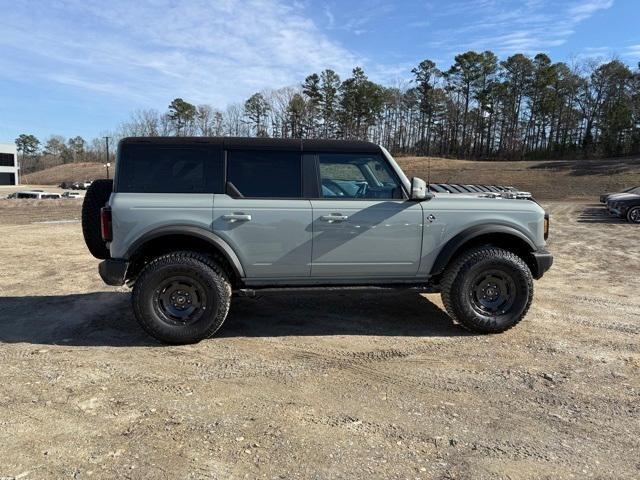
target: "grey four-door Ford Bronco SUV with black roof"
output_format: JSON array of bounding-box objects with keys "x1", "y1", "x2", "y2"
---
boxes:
[{"x1": 82, "y1": 137, "x2": 553, "y2": 344}]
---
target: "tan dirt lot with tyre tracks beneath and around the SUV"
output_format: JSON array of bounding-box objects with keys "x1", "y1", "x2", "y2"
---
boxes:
[{"x1": 0, "y1": 200, "x2": 640, "y2": 479}]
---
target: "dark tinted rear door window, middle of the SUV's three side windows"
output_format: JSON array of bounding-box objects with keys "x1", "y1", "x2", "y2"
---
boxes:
[{"x1": 227, "y1": 150, "x2": 302, "y2": 198}]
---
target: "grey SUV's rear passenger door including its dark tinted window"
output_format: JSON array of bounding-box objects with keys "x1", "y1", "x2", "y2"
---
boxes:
[{"x1": 213, "y1": 149, "x2": 312, "y2": 280}]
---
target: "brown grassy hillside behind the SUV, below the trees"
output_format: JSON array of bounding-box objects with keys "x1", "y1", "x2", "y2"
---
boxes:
[{"x1": 22, "y1": 157, "x2": 640, "y2": 199}]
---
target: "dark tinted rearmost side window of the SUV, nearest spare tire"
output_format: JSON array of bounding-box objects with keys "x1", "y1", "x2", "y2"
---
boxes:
[{"x1": 116, "y1": 145, "x2": 224, "y2": 193}]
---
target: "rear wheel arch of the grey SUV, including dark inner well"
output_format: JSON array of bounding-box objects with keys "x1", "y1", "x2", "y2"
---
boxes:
[{"x1": 124, "y1": 225, "x2": 245, "y2": 285}]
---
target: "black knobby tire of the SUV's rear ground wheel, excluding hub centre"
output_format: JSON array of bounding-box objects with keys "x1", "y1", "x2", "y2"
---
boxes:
[{"x1": 132, "y1": 251, "x2": 231, "y2": 345}]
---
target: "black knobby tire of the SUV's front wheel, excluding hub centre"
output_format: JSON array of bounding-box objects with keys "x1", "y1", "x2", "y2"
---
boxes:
[{"x1": 441, "y1": 246, "x2": 533, "y2": 333}]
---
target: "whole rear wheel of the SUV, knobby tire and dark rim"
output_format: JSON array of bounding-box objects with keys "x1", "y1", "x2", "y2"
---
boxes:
[{"x1": 132, "y1": 252, "x2": 231, "y2": 344}]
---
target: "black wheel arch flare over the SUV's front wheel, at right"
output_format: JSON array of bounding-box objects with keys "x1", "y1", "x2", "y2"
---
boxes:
[{"x1": 430, "y1": 225, "x2": 538, "y2": 277}]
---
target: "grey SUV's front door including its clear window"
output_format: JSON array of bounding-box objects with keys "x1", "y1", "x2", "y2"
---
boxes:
[{"x1": 311, "y1": 153, "x2": 423, "y2": 279}]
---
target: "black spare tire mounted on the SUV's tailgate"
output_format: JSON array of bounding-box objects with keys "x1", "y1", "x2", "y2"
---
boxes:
[{"x1": 82, "y1": 179, "x2": 113, "y2": 260}]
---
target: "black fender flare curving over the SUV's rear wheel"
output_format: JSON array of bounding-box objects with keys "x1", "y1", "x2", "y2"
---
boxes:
[{"x1": 124, "y1": 225, "x2": 245, "y2": 278}]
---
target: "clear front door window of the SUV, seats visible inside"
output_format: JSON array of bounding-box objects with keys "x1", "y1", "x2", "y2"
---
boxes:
[{"x1": 318, "y1": 153, "x2": 402, "y2": 199}]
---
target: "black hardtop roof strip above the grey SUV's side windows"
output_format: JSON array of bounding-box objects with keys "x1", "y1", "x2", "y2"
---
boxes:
[{"x1": 120, "y1": 137, "x2": 380, "y2": 153}]
